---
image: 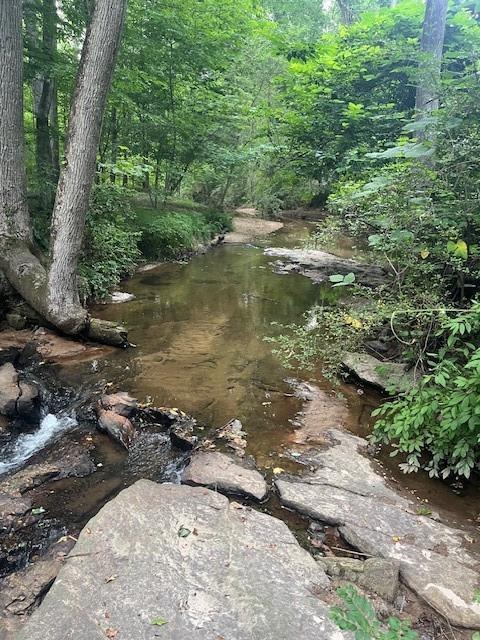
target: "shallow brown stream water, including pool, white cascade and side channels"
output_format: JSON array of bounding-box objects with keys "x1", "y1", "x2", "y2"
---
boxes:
[{"x1": 0, "y1": 222, "x2": 478, "y2": 564}]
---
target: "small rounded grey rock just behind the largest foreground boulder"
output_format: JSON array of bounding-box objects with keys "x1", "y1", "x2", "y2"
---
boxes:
[{"x1": 182, "y1": 451, "x2": 267, "y2": 500}]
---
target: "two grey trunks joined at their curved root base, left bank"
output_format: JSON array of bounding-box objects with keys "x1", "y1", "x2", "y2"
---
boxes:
[{"x1": 0, "y1": 0, "x2": 126, "y2": 344}]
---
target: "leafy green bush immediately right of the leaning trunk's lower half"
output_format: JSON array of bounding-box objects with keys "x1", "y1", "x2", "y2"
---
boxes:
[{"x1": 79, "y1": 184, "x2": 141, "y2": 299}]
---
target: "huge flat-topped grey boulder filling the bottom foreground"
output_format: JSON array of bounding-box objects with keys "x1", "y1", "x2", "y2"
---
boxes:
[{"x1": 18, "y1": 480, "x2": 350, "y2": 640}]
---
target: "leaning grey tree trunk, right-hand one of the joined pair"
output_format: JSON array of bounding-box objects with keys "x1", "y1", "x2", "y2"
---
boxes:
[{"x1": 48, "y1": 0, "x2": 126, "y2": 333}]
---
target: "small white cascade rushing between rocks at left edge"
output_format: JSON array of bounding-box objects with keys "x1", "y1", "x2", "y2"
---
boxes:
[{"x1": 0, "y1": 413, "x2": 77, "y2": 475}]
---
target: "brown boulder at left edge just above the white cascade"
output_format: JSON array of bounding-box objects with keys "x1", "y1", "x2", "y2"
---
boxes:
[{"x1": 0, "y1": 362, "x2": 40, "y2": 422}]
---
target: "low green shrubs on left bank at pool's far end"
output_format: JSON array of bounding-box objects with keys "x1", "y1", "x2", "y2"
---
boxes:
[{"x1": 138, "y1": 210, "x2": 232, "y2": 260}]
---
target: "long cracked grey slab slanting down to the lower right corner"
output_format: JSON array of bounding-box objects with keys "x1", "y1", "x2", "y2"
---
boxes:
[{"x1": 276, "y1": 430, "x2": 480, "y2": 629}]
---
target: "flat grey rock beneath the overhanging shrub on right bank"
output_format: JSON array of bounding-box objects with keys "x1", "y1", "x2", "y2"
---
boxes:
[{"x1": 342, "y1": 353, "x2": 414, "y2": 391}]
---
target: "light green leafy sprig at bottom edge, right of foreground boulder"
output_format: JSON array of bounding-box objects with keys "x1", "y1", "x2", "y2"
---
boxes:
[{"x1": 331, "y1": 585, "x2": 418, "y2": 640}]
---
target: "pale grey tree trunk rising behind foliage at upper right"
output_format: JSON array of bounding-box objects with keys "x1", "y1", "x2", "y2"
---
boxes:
[{"x1": 415, "y1": 0, "x2": 448, "y2": 116}]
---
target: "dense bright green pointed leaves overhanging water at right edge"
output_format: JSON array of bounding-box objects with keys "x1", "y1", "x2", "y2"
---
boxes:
[{"x1": 373, "y1": 303, "x2": 480, "y2": 478}]
